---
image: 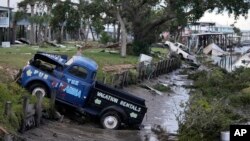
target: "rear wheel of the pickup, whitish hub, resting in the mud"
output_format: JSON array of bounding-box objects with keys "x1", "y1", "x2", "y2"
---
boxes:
[{"x1": 100, "y1": 111, "x2": 121, "y2": 130}]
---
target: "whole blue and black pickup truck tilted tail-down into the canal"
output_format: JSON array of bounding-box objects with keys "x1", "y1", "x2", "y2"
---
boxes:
[{"x1": 18, "y1": 52, "x2": 147, "y2": 129}]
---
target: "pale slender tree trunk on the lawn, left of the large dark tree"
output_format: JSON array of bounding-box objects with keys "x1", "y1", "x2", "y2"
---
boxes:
[{"x1": 116, "y1": 10, "x2": 127, "y2": 57}]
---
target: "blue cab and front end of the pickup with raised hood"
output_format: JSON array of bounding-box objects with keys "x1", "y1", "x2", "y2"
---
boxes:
[{"x1": 20, "y1": 52, "x2": 98, "y2": 106}]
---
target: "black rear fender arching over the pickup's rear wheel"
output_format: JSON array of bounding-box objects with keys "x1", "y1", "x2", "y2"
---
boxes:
[{"x1": 99, "y1": 106, "x2": 128, "y2": 122}]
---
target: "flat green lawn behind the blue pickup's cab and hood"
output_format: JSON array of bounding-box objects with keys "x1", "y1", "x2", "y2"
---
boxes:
[{"x1": 0, "y1": 43, "x2": 138, "y2": 80}]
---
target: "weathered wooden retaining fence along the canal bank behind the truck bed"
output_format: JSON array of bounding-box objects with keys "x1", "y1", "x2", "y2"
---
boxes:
[{"x1": 103, "y1": 58, "x2": 181, "y2": 88}]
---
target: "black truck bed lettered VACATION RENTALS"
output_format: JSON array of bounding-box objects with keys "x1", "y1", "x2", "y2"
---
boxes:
[{"x1": 87, "y1": 82, "x2": 147, "y2": 124}]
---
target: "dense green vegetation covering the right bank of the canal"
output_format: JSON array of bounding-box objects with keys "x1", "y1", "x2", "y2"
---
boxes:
[{"x1": 178, "y1": 68, "x2": 250, "y2": 141}]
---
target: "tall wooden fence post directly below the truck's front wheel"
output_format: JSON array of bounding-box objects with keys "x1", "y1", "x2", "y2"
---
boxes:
[{"x1": 36, "y1": 93, "x2": 43, "y2": 127}]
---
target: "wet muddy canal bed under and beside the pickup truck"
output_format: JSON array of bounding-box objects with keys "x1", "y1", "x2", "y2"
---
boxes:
[{"x1": 21, "y1": 68, "x2": 192, "y2": 141}]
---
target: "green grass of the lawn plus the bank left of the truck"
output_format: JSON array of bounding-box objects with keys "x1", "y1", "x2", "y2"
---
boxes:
[{"x1": 0, "y1": 42, "x2": 162, "y2": 131}]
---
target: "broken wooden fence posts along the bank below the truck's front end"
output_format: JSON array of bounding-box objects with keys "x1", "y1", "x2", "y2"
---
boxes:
[{"x1": 0, "y1": 90, "x2": 58, "y2": 141}]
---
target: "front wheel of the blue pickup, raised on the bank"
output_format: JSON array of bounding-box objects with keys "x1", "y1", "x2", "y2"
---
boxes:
[{"x1": 28, "y1": 83, "x2": 49, "y2": 97}]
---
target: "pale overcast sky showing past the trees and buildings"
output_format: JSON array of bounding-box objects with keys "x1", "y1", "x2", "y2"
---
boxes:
[{"x1": 0, "y1": 0, "x2": 250, "y2": 30}]
